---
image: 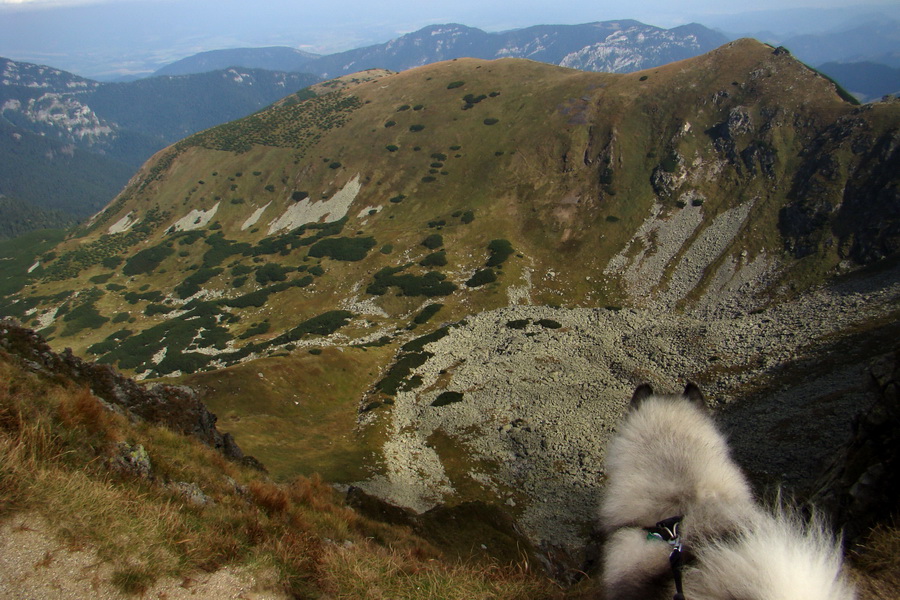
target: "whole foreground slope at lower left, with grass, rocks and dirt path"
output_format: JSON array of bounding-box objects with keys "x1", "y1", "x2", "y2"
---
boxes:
[{"x1": 0, "y1": 321, "x2": 555, "y2": 599}]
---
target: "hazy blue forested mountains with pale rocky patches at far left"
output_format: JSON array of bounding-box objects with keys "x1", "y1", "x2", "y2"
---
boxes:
[{"x1": 0, "y1": 58, "x2": 317, "y2": 218}]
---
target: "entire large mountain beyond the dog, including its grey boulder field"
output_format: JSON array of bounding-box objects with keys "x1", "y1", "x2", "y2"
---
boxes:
[{"x1": 3, "y1": 40, "x2": 900, "y2": 592}]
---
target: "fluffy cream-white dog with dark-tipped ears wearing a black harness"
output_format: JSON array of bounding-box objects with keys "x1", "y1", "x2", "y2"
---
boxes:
[{"x1": 601, "y1": 384, "x2": 855, "y2": 600}]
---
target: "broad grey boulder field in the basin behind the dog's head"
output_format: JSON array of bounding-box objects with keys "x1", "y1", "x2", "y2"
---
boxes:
[{"x1": 361, "y1": 258, "x2": 900, "y2": 548}]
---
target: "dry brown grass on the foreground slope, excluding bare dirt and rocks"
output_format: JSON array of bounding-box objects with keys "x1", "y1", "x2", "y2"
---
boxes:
[{"x1": 0, "y1": 352, "x2": 557, "y2": 599}]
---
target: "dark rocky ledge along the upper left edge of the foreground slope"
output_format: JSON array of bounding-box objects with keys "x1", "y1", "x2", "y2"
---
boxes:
[{"x1": 0, "y1": 321, "x2": 262, "y2": 468}]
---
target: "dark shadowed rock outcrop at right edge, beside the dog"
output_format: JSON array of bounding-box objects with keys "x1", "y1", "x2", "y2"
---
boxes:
[{"x1": 814, "y1": 349, "x2": 900, "y2": 543}]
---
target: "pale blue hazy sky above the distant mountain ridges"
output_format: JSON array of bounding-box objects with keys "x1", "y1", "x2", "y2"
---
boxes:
[{"x1": 0, "y1": 0, "x2": 900, "y2": 77}]
